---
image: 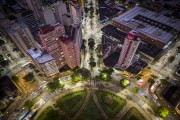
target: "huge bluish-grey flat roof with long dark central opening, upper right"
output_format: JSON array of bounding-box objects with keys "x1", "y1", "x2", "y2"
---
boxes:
[{"x1": 114, "y1": 6, "x2": 180, "y2": 43}]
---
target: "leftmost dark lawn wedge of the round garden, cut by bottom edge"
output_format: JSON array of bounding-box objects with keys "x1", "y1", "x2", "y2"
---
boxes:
[{"x1": 37, "y1": 106, "x2": 67, "y2": 120}]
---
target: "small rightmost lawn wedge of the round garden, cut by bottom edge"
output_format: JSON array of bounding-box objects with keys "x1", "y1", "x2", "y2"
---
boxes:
[{"x1": 122, "y1": 107, "x2": 145, "y2": 120}]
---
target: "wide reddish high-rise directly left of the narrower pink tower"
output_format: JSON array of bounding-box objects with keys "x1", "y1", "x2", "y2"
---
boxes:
[{"x1": 39, "y1": 24, "x2": 65, "y2": 68}]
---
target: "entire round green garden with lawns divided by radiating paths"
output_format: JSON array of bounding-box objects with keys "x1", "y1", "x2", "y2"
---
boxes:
[{"x1": 37, "y1": 90, "x2": 146, "y2": 120}]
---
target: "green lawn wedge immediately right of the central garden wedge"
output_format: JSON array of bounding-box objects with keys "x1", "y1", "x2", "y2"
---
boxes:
[{"x1": 96, "y1": 91, "x2": 126, "y2": 119}]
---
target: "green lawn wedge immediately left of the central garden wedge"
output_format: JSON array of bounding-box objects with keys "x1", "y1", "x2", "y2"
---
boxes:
[{"x1": 55, "y1": 91, "x2": 87, "y2": 117}]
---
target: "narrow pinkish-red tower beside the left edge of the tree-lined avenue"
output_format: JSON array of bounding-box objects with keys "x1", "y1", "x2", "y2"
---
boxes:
[{"x1": 61, "y1": 37, "x2": 80, "y2": 69}]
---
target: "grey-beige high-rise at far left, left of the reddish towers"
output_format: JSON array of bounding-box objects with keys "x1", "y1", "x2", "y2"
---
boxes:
[{"x1": 6, "y1": 22, "x2": 39, "y2": 55}]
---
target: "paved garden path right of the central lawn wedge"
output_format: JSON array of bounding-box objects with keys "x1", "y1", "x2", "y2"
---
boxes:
[{"x1": 92, "y1": 90, "x2": 109, "y2": 119}]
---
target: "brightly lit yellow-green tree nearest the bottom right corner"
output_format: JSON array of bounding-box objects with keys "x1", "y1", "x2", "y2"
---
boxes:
[{"x1": 156, "y1": 106, "x2": 169, "y2": 118}]
